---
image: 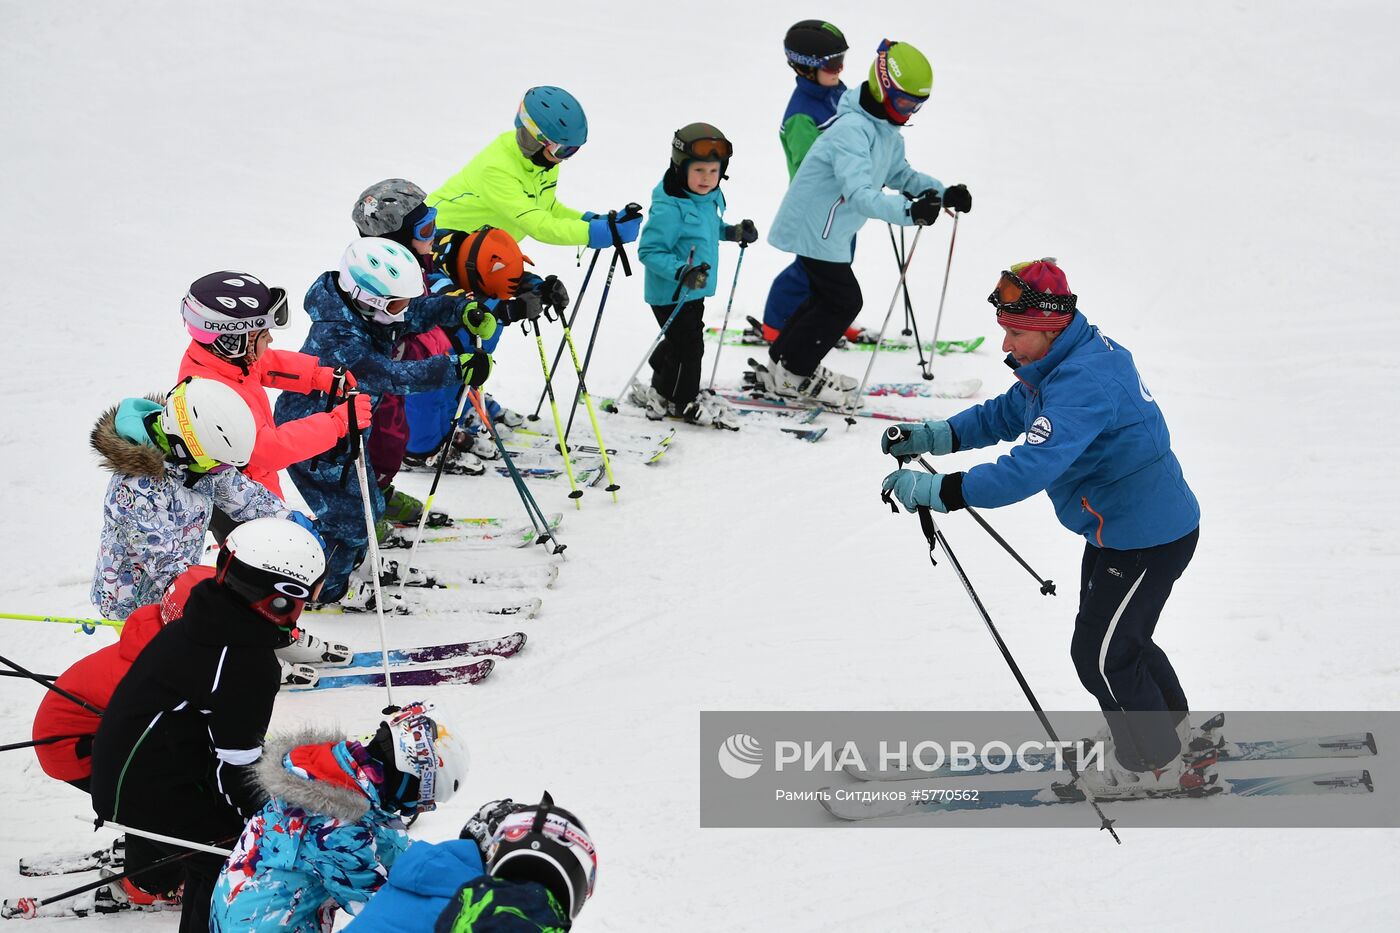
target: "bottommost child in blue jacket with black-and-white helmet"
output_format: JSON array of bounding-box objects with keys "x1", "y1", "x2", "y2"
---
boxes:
[{"x1": 346, "y1": 793, "x2": 598, "y2": 933}]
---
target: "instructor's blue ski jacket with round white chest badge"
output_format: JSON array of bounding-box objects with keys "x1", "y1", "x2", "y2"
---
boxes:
[{"x1": 948, "y1": 314, "x2": 1201, "y2": 551}]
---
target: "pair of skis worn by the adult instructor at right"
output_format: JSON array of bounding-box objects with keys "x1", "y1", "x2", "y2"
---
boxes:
[{"x1": 820, "y1": 733, "x2": 1376, "y2": 821}]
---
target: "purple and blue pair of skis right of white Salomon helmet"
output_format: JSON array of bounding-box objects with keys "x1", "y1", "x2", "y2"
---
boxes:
[{"x1": 287, "y1": 632, "x2": 526, "y2": 691}]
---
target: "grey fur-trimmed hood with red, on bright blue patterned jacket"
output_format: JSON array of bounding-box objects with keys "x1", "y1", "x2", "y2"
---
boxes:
[{"x1": 253, "y1": 727, "x2": 378, "y2": 822}]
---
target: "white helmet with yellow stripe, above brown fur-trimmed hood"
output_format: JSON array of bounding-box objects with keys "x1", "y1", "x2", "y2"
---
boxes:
[{"x1": 161, "y1": 377, "x2": 258, "y2": 474}]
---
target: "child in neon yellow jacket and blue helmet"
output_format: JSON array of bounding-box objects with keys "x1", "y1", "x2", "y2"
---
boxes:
[{"x1": 428, "y1": 87, "x2": 641, "y2": 249}]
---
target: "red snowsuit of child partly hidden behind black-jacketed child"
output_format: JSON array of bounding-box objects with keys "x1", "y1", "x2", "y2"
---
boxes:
[{"x1": 34, "y1": 566, "x2": 214, "y2": 780}]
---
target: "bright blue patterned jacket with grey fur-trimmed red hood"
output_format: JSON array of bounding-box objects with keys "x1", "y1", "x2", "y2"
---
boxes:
[{"x1": 209, "y1": 731, "x2": 409, "y2": 933}]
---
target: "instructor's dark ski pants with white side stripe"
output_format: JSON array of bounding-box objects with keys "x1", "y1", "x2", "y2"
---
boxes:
[{"x1": 1070, "y1": 528, "x2": 1200, "y2": 770}]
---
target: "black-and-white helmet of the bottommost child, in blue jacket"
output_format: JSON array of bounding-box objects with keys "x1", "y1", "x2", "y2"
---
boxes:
[{"x1": 486, "y1": 792, "x2": 598, "y2": 918}]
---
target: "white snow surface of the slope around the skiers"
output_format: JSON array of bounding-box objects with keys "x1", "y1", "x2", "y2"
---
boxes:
[{"x1": 0, "y1": 0, "x2": 1400, "y2": 930}]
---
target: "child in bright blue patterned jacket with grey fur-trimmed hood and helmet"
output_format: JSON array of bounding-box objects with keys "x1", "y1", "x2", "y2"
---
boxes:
[{"x1": 209, "y1": 703, "x2": 466, "y2": 933}]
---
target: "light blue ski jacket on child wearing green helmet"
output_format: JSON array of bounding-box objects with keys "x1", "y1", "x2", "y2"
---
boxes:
[{"x1": 769, "y1": 90, "x2": 944, "y2": 262}]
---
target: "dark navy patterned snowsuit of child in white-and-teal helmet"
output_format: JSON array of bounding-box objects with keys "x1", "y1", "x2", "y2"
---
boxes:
[{"x1": 273, "y1": 272, "x2": 463, "y2": 602}]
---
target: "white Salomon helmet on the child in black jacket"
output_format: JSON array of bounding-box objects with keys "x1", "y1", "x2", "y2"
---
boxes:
[{"x1": 214, "y1": 518, "x2": 326, "y2": 625}]
